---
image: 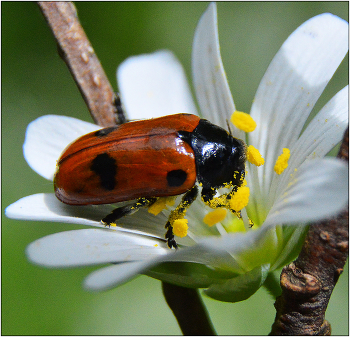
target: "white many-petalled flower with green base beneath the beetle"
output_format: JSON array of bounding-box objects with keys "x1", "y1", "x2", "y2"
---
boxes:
[{"x1": 6, "y1": 3, "x2": 348, "y2": 301}]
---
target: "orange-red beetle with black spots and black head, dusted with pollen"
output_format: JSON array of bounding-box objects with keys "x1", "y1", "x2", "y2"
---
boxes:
[{"x1": 54, "y1": 114, "x2": 246, "y2": 248}]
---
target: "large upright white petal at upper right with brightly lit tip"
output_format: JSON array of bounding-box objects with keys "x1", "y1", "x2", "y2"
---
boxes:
[{"x1": 249, "y1": 14, "x2": 348, "y2": 195}]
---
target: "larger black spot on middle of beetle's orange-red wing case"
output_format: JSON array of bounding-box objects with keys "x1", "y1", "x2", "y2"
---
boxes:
[{"x1": 91, "y1": 153, "x2": 117, "y2": 191}]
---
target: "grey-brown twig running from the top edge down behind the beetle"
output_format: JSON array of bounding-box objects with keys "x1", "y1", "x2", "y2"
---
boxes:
[{"x1": 38, "y1": 1, "x2": 120, "y2": 126}]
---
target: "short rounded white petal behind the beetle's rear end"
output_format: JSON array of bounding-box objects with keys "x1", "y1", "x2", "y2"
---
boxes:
[{"x1": 23, "y1": 115, "x2": 101, "y2": 180}]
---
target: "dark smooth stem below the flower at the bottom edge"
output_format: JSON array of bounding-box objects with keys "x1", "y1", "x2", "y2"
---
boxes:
[{"x1": 162, "y1": 282, "x2": 216, "y2": 336}]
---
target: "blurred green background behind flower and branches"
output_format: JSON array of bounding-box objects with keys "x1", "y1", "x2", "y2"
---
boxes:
[{"x1": 2, "y1": 2, "x2": 348, "y2": 335}]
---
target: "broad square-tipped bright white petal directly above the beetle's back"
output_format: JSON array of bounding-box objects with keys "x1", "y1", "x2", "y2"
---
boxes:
[{"x1": 117, "y1": 50, "x2": 197, "y2": 119}]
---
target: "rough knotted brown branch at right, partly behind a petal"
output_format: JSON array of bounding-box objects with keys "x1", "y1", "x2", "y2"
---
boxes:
[{"x1": 271, "y1": 129, "x2": 349, "y2": 335}]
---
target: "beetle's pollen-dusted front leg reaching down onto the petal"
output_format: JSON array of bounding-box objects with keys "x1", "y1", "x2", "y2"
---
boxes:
[{"x1": 165, "y1": 185, "x2": 198, "y2": 249}]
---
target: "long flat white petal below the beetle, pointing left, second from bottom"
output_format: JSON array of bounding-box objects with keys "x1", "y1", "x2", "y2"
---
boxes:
[{"x1": 27, "y1": 229, "x2": 170, "y2": 267}]
